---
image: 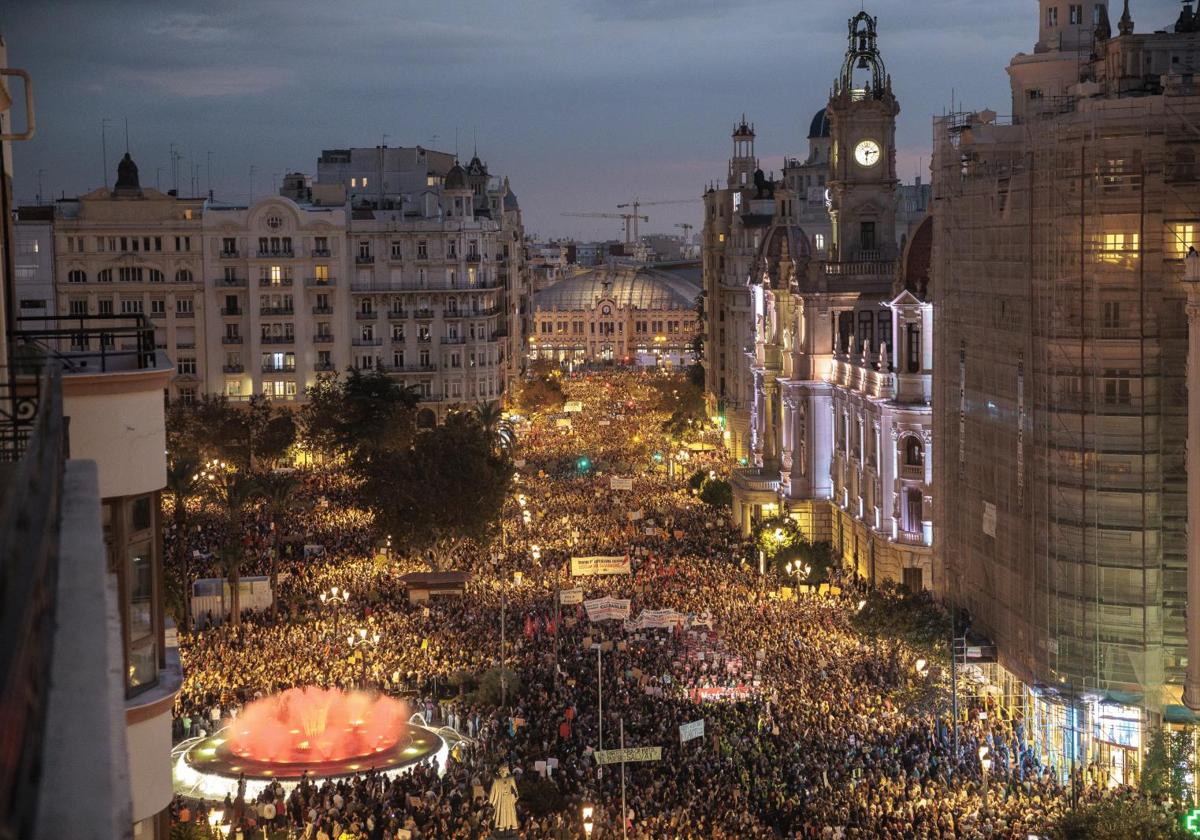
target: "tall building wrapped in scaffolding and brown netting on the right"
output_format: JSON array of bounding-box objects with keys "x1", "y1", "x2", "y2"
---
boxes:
[{"x1": 932, "y1": 0, "x2": 1200, "y2": 781}]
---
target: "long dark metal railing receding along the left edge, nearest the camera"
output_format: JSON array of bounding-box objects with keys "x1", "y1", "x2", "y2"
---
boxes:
[{"x1": 0, "y1": 364, "x2": 67, "y2": 838}]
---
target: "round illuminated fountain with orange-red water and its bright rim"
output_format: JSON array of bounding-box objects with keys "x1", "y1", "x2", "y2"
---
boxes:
[{"x1": 175, "y1": 685, "x2": 445, "y2": 796}]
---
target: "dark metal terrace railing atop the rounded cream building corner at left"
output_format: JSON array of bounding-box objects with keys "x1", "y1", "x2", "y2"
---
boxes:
[{"x1": 12, "y1": 314, "x2": 158, "y2": 373}]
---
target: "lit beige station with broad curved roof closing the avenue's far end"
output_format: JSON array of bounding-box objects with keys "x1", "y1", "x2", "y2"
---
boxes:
[{"x1": 528, "y1": 263, "x2": 701, "y2": 367}]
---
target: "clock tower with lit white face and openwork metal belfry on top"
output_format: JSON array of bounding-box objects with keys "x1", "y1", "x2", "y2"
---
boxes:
[{"x1": 827, "y1": 12, "x2": 900, "y2": 263}]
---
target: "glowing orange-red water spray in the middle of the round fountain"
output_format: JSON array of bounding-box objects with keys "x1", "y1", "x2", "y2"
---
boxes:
[{"x1": 228, "y1": 685, "x2": 408, "y2": 764}]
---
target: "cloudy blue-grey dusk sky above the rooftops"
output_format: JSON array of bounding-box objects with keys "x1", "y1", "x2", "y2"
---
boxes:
[{"x1": 0, "y1": 0, "x2": 1178, "y2": 238}]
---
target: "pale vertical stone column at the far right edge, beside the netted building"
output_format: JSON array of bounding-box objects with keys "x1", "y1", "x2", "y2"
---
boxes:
[{"x1": 1183, "y1": 248, "x2": 1200, "y2": 709}]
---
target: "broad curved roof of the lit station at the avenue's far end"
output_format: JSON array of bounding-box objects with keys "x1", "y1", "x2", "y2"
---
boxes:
[{"x1": 533, "y1": 263, "x2": 701, "y2": 311}]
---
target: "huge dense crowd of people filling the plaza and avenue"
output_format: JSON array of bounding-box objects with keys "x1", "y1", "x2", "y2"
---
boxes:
[{"x1": 168, "y1": 372, "x2": 1161, "y2": 840}]
